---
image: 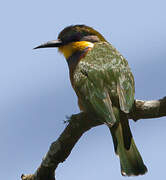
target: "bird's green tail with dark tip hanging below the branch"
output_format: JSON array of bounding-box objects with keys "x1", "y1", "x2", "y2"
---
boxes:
[{"x1": 109, "y1": 113, "x2": 147, "y2": 176}]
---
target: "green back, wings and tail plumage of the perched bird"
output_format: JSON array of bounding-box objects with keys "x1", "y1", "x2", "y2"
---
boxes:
[{"x1": 73, "y1": 42, "x2": 147, "y2": 176}]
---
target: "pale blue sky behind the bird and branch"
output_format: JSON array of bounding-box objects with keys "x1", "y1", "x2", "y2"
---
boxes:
[{"x1": 0, "y1": 0, "x2": 166, "y2": 180}]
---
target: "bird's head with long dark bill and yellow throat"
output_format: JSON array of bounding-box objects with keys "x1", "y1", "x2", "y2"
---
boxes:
[{"x1": 34, "y1": 25, "x2": 106, "y2": 59}]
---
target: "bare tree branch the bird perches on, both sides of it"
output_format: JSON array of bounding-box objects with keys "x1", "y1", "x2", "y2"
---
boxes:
[{"x1": 21, "y1": 97, "x2": 166, "y2": 180}]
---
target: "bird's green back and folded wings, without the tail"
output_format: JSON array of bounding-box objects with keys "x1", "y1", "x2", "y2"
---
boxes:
[{"x1": 74, "y1": 42, "x2": 134, "y2": 124}]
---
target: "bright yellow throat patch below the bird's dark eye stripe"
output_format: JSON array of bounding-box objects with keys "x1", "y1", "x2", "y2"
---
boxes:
[{"x1": 59, "y1": 41, "x2": 94, "y2": 59}]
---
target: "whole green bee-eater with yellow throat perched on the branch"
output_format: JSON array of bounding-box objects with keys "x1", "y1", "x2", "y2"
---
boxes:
[{"x1": 34, "y1": 24, "x2": 147, "y2": 176}]
